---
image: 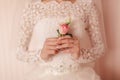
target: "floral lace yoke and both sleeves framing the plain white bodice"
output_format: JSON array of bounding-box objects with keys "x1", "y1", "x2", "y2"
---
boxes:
[{"x1": 17, "y1": 0, "x2": 104, "y2": 63}]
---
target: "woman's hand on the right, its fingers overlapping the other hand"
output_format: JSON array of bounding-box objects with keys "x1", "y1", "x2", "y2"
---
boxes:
[{"x1": 57, "y1": 36, "x2": 80, "y2": 59}]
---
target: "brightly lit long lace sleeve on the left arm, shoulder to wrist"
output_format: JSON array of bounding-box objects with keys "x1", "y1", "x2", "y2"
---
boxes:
[{"x1": 17, "y1": 3, "x2": 41, "y2": 63}]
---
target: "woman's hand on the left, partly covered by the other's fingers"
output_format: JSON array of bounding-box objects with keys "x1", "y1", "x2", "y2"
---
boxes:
[{"x1": 40, "y1": 37, "x2": 58, "y2": 60}]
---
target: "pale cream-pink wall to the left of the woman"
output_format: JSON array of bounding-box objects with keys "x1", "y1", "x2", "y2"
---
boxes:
[{"x1": 0, "y1": 0, "x2": 29, "y2": 80}]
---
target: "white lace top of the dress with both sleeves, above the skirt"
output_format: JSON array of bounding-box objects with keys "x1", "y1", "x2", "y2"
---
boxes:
[{"x1": 17, "y1": 0, "x2": 104, "y2": 67}]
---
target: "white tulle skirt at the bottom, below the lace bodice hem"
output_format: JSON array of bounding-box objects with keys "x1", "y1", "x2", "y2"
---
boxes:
[{"x1": 24, "y1": 64, "x2": 101, "y2": 80}]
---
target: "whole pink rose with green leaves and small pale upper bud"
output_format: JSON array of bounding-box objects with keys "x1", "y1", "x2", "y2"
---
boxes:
[{"x1": 57, "y1": 17, "x2": 72, "y2": 37}]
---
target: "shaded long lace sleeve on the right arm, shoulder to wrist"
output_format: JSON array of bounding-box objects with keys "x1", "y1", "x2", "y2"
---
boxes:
[{"x1": 78, "y1": 1, "x2": 104, "y2": 63}]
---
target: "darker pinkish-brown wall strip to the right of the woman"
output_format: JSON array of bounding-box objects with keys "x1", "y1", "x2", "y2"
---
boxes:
[{"x1": 101, "y1": 0, "x2": 120, "y2": 80}]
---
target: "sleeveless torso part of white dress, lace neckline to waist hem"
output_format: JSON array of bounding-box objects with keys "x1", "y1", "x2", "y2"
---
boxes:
[{"x1": 30, "y1": 0, "x2": 94, "y2": 73}]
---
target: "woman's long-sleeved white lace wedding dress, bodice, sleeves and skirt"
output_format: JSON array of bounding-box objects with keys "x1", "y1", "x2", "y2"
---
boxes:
[{"x1": 17, "y1": 0, "x2": 104, "y2": 80}]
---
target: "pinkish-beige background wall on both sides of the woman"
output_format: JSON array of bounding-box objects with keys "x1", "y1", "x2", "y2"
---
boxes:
[{"x1": 0, "y1": 0, "x2": 120, "y2": 80}]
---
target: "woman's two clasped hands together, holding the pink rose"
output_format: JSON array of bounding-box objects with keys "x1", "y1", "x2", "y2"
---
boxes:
[{"x1": 40, "y1": 36, "x2": 80, "y2": 60}]
